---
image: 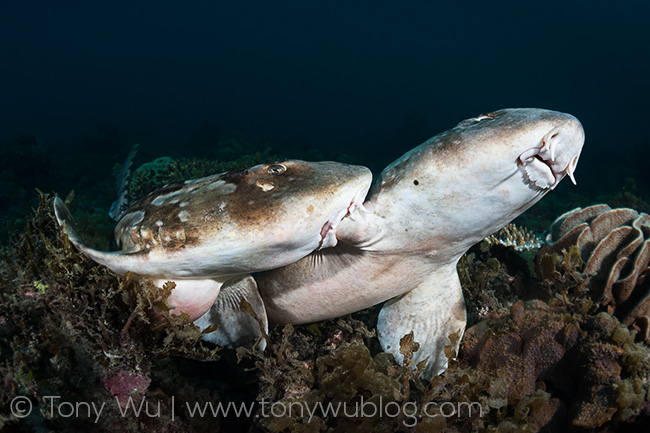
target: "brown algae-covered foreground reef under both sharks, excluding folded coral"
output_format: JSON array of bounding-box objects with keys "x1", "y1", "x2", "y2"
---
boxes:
[{"x1": 0, "y1": 187, "x2": 650, "y2": 433}]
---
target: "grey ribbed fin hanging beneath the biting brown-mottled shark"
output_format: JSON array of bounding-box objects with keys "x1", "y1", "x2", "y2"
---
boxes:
[{"x1": 194, "y1": 275, "x2": 269, "y2": 349}]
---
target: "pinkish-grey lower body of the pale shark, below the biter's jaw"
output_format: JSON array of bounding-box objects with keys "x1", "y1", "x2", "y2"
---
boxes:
[{"x1": 255, "y1": 247, "x2": 430, "y2": 324}]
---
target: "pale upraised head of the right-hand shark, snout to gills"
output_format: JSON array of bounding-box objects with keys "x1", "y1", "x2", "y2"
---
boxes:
[{"x1": 339, "y1": 108, "x2": 584, "y2": 261}]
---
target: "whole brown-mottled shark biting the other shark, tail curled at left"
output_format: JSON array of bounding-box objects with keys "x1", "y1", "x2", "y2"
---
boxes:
[{"x1": 54, "y1": 160, "x2": 372, "y2": 342}]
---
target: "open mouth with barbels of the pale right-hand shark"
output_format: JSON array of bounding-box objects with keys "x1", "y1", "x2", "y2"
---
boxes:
[{"x1": 517, "y1": 127, "x2": 578, "y2": 189}]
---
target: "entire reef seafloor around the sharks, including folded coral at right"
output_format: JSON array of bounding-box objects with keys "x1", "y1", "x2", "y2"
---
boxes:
[{"x1": 0, "y1": 130, "x2": 650, "y2": 432}]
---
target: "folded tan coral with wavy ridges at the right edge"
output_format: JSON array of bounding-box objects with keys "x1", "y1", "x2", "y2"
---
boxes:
[{"x1": 536, "y1": 204, "x2": 650, "y2": 339}]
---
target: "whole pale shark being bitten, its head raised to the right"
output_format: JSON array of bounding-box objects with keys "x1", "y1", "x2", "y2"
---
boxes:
[{"x1": 255, "y1": 109, "x2": 584, "y2": 376}]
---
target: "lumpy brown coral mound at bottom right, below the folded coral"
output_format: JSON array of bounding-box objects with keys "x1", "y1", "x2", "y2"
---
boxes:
[{"x1": 461, "y1": 300, "x2": 650, "y2": 429}]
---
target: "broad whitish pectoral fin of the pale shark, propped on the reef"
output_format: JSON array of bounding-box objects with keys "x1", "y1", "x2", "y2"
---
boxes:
[{"x1": 377, "y1": 262, "x2": 467, "y2": 379}]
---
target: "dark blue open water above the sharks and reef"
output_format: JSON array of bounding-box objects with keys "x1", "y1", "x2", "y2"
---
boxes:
[{"x1": 0, "y1": 0, "x2": 650, "y2": 236}]
